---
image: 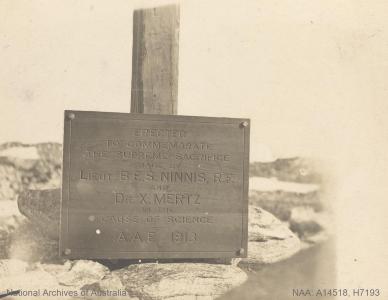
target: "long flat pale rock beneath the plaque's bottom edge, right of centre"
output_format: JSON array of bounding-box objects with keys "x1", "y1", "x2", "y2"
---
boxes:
[{"x1": 113, "y1": 263, "x2": 247, "y2": 300}]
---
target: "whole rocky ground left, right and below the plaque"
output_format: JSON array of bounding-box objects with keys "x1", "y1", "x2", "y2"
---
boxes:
[{"x1": 0, "y1": 143, "x2": 328, "y2": 300}]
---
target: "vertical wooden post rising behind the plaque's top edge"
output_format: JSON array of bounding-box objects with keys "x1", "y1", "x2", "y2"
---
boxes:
[{"x1": 131, "y1": 5, "x2": 179, "y2": 115}]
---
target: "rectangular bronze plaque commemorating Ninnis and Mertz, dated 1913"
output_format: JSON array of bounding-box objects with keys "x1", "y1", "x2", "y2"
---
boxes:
[{"x1": 60, "y1": 111, "x2": 250, "y2": 259}]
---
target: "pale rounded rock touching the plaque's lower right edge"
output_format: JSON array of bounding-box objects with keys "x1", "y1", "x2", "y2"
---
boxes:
[{"x1": 238, "y1": 205, "x2": 301, "y2": 268}]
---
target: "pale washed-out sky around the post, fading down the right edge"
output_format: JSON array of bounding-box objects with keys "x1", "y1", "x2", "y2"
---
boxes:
[{"x1": 0, "y1": 0, "x2": 388, "y2": 288}]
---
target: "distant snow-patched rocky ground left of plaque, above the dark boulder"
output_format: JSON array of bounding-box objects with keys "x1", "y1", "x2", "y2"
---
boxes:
[{"x1": 0, "y1": 142, "x2": 62, "y2": 201}]
